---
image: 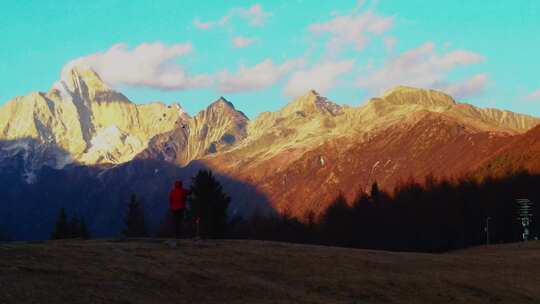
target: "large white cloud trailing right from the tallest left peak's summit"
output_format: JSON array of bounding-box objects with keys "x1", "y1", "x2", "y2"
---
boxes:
[{"x1": 62, "y1": 42, "x2": 211, "y2": 90}]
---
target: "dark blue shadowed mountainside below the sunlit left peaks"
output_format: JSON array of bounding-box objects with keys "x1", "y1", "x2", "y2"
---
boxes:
[{"x1": 0, "y1": 138, "x2": 275, "y2": 240}]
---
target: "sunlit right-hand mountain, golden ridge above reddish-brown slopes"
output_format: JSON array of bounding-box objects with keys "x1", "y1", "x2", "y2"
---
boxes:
[{"x1": 193, "y1": 87, "x2": 540, "y2": 217}]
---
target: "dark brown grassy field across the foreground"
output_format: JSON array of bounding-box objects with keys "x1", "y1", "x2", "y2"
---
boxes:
[{"x1": 0, "y1": 240, "x2": 540, "y2": 304}]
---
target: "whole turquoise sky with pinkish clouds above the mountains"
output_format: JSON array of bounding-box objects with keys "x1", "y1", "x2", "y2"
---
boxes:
[{"x1": 0, "y1": 0, "x2": 540, "y2": 117}]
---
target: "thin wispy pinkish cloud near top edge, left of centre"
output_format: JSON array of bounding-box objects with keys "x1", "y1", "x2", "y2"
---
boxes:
[{"x1": 193, "y1": 4, "x2": 272, "y2": 31}]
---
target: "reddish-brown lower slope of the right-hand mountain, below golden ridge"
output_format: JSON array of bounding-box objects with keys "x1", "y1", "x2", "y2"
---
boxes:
[{"x1": 207, "y1": 112, "x2": 512, "y2": 216}]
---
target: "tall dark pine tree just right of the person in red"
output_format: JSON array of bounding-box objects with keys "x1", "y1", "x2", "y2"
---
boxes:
[{"x1": 190, "y1": 170, "x2": 231, "y2": 237}]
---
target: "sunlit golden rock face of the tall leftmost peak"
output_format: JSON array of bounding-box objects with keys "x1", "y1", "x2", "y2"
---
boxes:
[{"x1": 0, "y1": 67, "x2": 188, "y2": 176}]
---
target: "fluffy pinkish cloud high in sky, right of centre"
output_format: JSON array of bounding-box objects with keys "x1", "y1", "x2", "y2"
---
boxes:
[{"x1": 308, "y1": 10, "x2": 394, "y2": 51}]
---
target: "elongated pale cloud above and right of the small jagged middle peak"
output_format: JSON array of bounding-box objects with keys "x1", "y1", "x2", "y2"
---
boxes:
[{"x1": 218, "y1": 59, "x2": 304, "y2": 93}]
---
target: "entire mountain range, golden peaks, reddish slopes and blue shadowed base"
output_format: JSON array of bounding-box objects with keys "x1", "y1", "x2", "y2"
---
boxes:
[{"x1": 0, "y1": 67, "x2": 540, "y2": 238}]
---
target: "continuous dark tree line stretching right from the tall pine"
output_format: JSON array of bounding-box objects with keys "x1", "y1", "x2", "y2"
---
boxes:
[{"x1": 230, "y1": 171, "x2": 540, "y2": 252}]
